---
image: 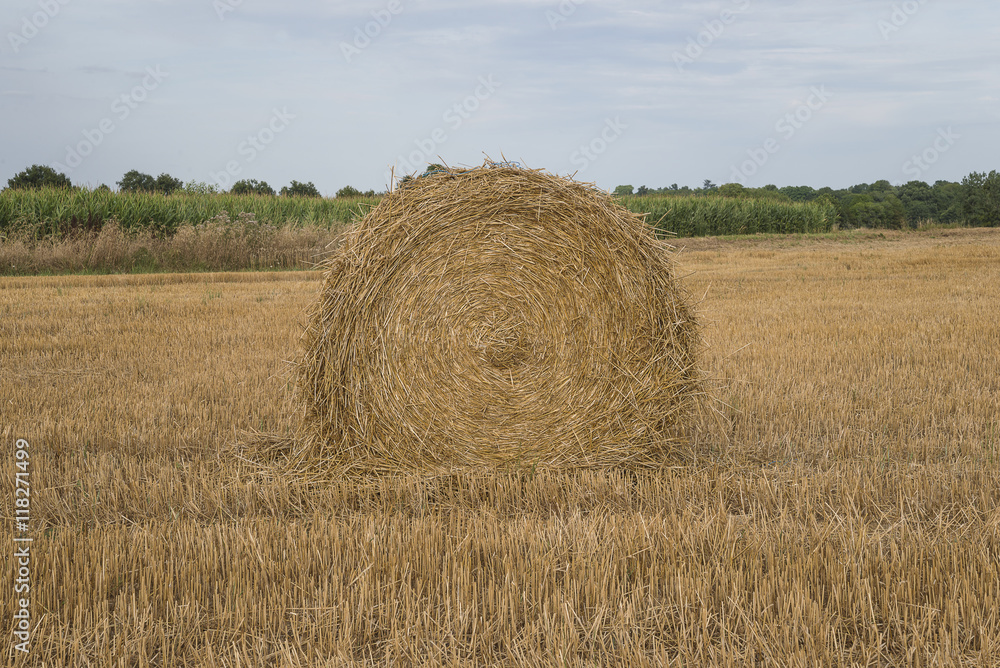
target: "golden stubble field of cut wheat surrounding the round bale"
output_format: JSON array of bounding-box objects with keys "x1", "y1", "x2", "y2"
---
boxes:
[{"x1": 0, "y1": 229, "x2": 1000, "y2": 667}]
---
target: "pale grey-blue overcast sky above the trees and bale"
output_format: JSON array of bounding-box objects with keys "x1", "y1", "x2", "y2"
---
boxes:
[{"x1": 0, "y1": 0, "x2": 1000, "y2": 195}]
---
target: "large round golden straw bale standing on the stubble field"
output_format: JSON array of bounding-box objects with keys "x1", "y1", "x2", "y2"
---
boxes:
[{"x1": 298, "y1": 163, "x2": 698, "y2": 470}]
